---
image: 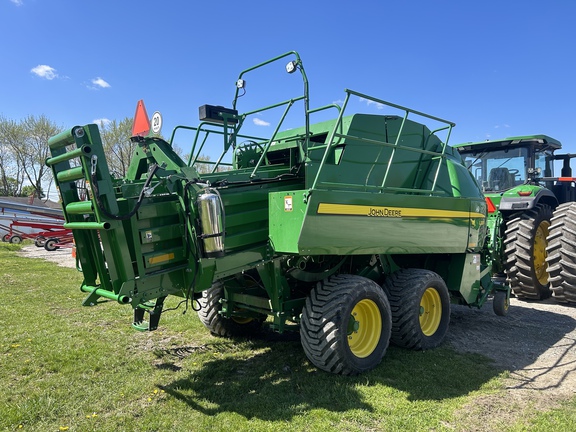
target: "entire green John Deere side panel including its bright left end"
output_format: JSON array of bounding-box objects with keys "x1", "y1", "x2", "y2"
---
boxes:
[{"x1": 270, "y1": 186, "x2": 486, "y2": 255}]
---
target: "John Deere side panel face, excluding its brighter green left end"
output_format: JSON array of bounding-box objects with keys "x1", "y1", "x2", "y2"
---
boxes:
[{"x1": 298, "y1": 191, "x2": 484, "y2": 255}]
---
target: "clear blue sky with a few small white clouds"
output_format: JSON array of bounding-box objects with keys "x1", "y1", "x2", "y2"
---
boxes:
[{"x1": 0, "y1": 0, "x2": 576, "y2": 162}]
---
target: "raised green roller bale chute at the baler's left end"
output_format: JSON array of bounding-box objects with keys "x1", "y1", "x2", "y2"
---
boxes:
[{"x1": 46, "y1": 124, "x2": 163, "y2": 330}]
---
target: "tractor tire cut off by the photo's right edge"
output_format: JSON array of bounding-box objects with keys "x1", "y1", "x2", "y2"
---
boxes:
[{"x1": 546, "y1": 202, "x2": 576, "y2": 303}]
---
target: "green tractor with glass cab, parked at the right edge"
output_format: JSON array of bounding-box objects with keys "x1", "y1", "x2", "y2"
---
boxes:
[{"x1": 454, "y1": 135, "x2": 576, "y2": 301}]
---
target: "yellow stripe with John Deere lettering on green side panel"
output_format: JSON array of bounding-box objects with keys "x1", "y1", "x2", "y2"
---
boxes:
[{"x1": 318, "y1": 203, "x2": 486, "y2": 219}]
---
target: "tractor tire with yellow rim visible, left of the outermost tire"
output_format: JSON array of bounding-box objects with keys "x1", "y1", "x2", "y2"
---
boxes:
[{"x1": 504, "y1": 204, "x2": 552, "y2": 300}]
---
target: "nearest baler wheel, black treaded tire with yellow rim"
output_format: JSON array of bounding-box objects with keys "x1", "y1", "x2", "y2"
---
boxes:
[{"x1": 300, "y1": 275, "x2": 392, "y2": 375}]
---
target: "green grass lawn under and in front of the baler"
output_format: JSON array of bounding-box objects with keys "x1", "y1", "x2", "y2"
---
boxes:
[{"x1": 0, "y1": 244, "x2": 576, "y2": 432}]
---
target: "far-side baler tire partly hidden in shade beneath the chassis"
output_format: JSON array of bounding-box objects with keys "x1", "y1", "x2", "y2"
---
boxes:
[{"x1": 197, "y1": 283, "x2": 266, "y2": 337}]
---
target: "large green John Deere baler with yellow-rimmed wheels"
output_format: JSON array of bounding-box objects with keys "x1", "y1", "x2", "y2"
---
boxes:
[{"x1": 47, "y1": 52, "x2": 510, "y2": 375}]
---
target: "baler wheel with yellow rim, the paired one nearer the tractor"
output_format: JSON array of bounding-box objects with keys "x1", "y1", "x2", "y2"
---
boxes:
[{"x1": 384, "y1": 269, "x2": 450, "y2": 350}]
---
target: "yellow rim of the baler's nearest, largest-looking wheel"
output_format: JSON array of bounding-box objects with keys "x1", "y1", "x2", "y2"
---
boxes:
[{"x1": 348, "y1": 299, "x2": 382, "y2": 358}]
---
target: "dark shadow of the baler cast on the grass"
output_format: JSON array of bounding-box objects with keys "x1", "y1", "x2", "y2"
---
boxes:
[{"x1": 157, "y1": 330, "x2": 500, "y2": 420}]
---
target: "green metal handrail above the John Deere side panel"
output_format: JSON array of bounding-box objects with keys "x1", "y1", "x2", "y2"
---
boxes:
[{"x1": 310, "y1": 89, "x2": 456, "y2": 193}]
